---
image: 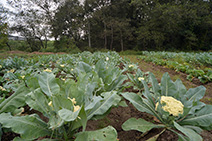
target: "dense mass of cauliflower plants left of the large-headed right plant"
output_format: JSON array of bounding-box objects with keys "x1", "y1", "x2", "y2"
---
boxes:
[{"x1": 0, "y1": 52, "x2": 126, "y2": 140}]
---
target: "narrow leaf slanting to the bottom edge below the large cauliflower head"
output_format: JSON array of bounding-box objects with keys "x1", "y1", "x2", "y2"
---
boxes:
[{"x1": 174, "y1": 121, "x2": 203, "y2": 141}]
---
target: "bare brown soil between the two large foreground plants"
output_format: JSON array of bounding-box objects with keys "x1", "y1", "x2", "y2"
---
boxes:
[{"x1": 86, "y1": 102, "x2": 178, "y2": 141}]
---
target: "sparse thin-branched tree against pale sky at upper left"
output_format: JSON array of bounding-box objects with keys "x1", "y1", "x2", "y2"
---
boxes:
[{"x1": 6, "y1": 0, "x2": 57, "y2": 51}]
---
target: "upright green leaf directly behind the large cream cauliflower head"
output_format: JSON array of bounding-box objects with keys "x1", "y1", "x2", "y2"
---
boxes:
[{"x1": 161, "y1": 72, "x2": 177, "y2": 97}]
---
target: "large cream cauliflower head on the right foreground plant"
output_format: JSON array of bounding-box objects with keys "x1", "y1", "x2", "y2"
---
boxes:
[{"x1": 155, "y1": 96, "x2": 184, "y2": 116}]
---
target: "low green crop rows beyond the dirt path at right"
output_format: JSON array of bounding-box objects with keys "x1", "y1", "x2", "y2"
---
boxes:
[{"x1": 138, "y1": 51, "x2": 212, "y2": 83}]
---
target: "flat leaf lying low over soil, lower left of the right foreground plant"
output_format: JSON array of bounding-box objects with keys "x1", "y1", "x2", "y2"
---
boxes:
[{"x1": 122, "y1": 118, "x2": 164, "y2": 133}]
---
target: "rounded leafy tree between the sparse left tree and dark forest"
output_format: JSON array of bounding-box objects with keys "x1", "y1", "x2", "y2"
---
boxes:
[{"x1": 51, "y1": 0, "x2": 83, "y2": 48}]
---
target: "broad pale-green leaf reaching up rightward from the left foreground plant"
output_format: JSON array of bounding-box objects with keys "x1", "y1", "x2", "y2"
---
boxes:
[{"x1": 86, "y1": 91, "x2": 121, "y2": 119}]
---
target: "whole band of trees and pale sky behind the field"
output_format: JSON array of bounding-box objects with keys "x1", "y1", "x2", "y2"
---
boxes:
[{"x1": 0, "y1": 0, "x2": 212, "y2": 52}]
